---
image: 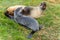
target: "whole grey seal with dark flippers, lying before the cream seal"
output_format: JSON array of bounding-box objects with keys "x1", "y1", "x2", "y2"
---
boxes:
[{"x1": 5, "y1": 8, "x2": 42, "y2": 38}]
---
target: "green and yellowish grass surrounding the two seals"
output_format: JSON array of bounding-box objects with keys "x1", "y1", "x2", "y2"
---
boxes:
[{"x1": 0, "y1": 0, "x2": 60, "y2": 40}]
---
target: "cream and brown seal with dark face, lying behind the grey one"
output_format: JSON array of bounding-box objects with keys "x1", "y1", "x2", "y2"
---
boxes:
[{"x1": 5, "y1": 2, "x2": 46, "y2": 18}]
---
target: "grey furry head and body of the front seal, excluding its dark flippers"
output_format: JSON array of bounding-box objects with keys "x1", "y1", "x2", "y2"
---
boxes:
[{"x1": 14, "y1": 8, "x2": 39, "y2": 31}]
